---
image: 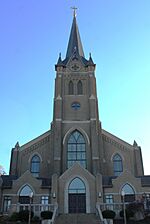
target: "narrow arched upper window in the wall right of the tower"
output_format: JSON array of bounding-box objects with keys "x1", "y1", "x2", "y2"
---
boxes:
[{"x1": 113, "y1": 154, "x2": 123, "y2": 176}]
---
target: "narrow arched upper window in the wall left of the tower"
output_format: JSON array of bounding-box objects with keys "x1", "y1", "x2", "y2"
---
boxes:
[{"x1": 30, "y1": 155, "x2": 40, "y2": 177}]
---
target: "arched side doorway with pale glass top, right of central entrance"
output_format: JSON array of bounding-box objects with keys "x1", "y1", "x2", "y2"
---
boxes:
[{"x1": 121, "y1": 184, "x2": 135, "y2": 202}]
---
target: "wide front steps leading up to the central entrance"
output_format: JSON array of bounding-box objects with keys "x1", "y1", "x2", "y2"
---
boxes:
[{"x1": 55, "y1": 213, "x2": 101, "y2": 224}]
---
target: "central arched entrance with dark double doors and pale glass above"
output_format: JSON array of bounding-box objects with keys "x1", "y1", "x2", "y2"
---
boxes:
[{"x1": 68, "y1": 178, "x2": 86, "y2": 213}]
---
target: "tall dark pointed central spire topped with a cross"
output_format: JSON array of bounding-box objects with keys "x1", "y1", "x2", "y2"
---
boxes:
[{"x1": 66, "y1": 7, "x2": 84, "y2": 58}]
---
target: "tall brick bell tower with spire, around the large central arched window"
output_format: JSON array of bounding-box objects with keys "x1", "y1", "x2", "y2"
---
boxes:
[{"x1": 52, "y1": 10, "x2": 103, "y2": 174}]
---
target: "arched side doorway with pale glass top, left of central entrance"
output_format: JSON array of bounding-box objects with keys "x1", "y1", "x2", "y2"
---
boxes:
[{"x1": 19, "y1": 185, "x2": 33, "y2": 204}]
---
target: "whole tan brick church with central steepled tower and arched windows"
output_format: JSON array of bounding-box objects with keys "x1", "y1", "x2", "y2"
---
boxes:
[{"x1": 0, "y1": 12, "x2": 150, "y2": 219}]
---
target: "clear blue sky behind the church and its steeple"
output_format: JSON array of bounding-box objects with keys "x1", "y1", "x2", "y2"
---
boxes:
[{"x1": 0, "y1": 0, "x2": 150, "y2": 174}]
